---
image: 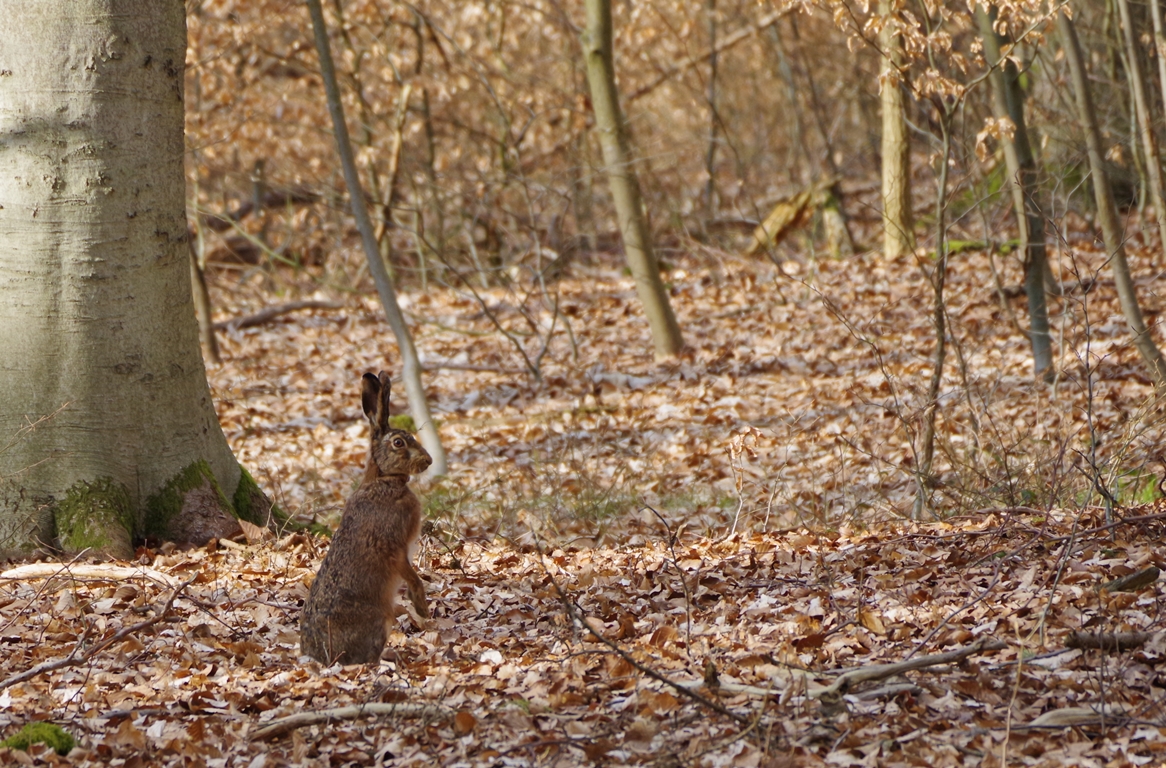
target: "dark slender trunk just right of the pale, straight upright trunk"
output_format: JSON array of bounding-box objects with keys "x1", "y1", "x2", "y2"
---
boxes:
[{"x1": 976, "y1": 5, "x2": 1054, "y2": 381}]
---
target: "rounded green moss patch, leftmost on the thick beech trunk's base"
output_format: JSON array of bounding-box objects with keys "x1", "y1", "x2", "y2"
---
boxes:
[{"x1": 54, "y1": 478, "x2": 134, "y2": 559}]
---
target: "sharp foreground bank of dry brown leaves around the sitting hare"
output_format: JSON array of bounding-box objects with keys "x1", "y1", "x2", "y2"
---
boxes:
[{"x1": 0, "y1": 515, "x2": 1166, "y2": 766}]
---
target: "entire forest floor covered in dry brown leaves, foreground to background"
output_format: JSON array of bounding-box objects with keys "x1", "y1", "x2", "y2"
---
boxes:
[{"x1": 0, "y1": 231, "x2": 1166, "y2": 768}]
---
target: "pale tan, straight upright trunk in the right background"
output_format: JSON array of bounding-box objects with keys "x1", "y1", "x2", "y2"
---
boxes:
[{"x1": 879, "y1": 0, "x2": 915, "y2": 260}]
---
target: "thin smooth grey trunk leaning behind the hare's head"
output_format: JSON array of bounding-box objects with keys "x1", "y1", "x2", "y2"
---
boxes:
[{"x1": 308, "y1": 0, "x2": 448, "y2": 477}]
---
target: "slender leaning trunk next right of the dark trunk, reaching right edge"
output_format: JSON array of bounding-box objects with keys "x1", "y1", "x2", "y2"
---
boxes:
[{"x1": 1056, "y1": 13, "x2": 1166, "y2": 390}]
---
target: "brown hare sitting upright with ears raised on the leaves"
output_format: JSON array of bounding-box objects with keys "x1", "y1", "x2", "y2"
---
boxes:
[{"x1": 300, "y1": 371, "x2": 433, "y2": 664}]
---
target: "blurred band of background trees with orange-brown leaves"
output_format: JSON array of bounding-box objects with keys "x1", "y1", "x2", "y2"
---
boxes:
[{"x1": 187, "y1": 0, "x2": 1166, "y2": 519}]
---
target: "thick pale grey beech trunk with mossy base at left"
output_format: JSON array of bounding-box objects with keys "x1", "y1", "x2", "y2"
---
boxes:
[{"x1": 0, "y1": 0, "x2": 269, "y2": 557}]
